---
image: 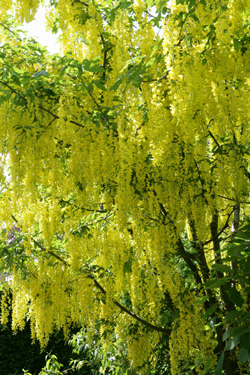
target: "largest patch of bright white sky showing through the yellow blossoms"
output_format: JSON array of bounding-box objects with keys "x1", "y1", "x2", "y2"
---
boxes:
[{"x1": 21, "y1": 1, "x2": 59, "y2": 54}]
